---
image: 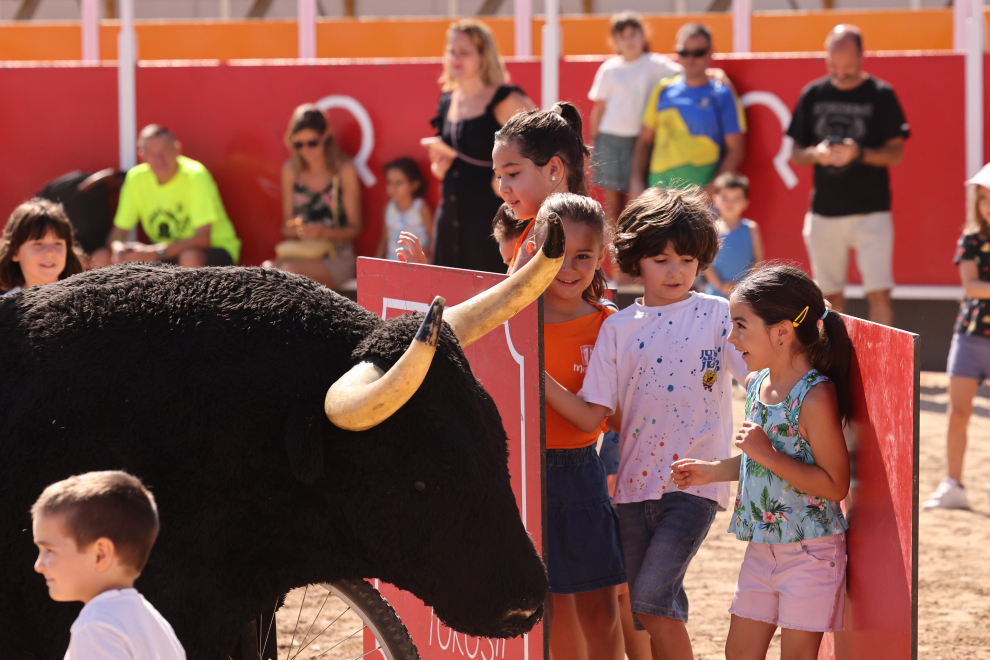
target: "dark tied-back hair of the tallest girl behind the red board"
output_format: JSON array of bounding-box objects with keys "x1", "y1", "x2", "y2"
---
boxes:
[{"x1": 495, "y1": 101, "x2": 591, "y2": 195}]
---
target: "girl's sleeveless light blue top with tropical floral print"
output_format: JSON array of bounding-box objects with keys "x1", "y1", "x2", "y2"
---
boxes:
[{"x1": 729, "y1": 369, "x2": 849, "y2": 543}]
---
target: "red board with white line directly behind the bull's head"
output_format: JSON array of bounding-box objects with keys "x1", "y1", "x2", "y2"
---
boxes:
[{"x1": 357, "y1": 258, "x2": 545, "y2": 660}]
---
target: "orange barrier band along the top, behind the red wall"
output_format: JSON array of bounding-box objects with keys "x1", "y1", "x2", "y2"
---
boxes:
[{"x1": 0, "y1": 9, "x2": 990, "y2": 61}]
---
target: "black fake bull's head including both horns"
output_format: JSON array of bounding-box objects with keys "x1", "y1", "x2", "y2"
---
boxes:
[{"x1": 325, "y1": 220, "x2": 564, "y2": 637}]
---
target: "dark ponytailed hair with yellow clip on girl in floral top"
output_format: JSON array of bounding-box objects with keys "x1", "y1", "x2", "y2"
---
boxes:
[{"x1": 732, "y1": 264, "x2": 852, "y2": 421}]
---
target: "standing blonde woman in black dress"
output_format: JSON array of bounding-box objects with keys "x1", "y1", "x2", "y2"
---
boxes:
[{"x1": 430, "y1": 20, "x2": 533, "y2": 273}]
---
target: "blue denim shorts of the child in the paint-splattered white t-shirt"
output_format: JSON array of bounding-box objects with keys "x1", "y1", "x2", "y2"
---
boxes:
[{"x1": 618, "y1": 492, "x2": 718, "y2": 630}]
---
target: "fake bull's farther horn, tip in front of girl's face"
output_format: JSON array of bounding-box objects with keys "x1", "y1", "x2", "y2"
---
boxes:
[{"x1": 447, "y1": 215, "x2": 564, "y2": 347}]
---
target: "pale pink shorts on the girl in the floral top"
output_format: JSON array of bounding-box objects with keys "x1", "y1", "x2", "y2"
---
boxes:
[{"x1": 729, "y1": 534, "x2": 846, "y2": 632}]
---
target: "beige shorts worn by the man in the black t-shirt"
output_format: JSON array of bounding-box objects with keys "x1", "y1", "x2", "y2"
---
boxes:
[{"x1": 802, "y1": 211, "x2": 894, "y2": 295}]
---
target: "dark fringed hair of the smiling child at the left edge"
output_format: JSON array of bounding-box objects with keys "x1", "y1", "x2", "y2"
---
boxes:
[{"x1": 0, "y1": 197, "x2": 82, "y2": 291}]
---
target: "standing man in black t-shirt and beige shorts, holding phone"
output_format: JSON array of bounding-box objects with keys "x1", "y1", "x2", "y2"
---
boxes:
[{"x1": 787, "y1": 25, "x2": 910, "y2": 325}]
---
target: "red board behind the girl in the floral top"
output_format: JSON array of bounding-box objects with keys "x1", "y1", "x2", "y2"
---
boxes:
[{"x1": 819, "y1": 316, "x2": 920, "y2": 660}]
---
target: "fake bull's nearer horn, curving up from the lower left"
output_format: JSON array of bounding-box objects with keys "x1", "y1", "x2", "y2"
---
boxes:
[{"x1": 323, "y1": 296, "x2": 444, "y2": 431}]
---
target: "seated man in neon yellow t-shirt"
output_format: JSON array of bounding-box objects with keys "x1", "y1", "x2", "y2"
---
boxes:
[{"x1": 92, "y1": 124, "x2": 241, "y2": 268}]
